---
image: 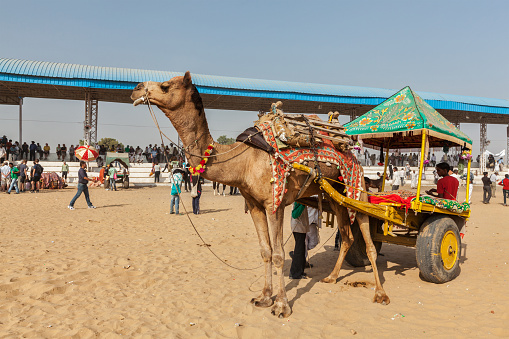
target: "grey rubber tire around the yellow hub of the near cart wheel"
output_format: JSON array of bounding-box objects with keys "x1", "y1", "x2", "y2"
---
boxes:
[{"x1": 415, "y1": 215, "x2": 461, "y2": 284}]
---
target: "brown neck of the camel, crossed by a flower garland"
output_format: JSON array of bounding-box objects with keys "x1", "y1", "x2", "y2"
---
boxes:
[{"x1": 160, "y1": 97, "x2": 246, "y2": 185}]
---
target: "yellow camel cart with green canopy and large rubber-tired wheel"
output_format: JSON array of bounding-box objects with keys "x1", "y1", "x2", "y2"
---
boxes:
[{"x1": 293, "y1": 87, "x2": 472, "y2": 283}]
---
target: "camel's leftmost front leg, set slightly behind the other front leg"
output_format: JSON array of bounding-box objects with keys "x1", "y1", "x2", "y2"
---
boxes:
[{"x1": 246, "y1": 198, "x2": 274, "y2": 307}]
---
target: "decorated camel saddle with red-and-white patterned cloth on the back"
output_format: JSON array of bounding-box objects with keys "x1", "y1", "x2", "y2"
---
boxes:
[{"x1": 237, "y1": 101, "x2": 363, "y2": 220}]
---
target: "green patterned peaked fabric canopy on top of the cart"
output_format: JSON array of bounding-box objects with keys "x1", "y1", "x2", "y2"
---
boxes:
[{"x1": 345, "y1": 86, "x2": 472, "y2": 149}]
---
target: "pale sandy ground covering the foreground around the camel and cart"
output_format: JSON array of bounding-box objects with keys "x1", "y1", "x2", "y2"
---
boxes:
[{"x1": 0, "y1": 187, "x2": 509, "y2": 338}]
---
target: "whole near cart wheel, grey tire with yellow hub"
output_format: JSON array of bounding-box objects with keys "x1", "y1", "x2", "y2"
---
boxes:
[{"x1": 416, "y1": 214, "x2": 461, "y2": 284}]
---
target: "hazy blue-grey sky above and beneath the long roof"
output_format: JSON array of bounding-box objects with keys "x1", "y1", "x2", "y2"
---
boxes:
[{"x1": 0, "y1": 0, "x2": 509, "y2": 152}]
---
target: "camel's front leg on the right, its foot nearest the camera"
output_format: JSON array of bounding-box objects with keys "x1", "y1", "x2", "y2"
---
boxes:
[{"x1": 266, "y1": 204, "x2": 292, "y2": 318}]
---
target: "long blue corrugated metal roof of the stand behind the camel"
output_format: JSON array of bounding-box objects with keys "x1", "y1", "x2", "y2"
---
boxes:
[{"x1": 0, "y1": 58, "x2": 509, "y2": 114}]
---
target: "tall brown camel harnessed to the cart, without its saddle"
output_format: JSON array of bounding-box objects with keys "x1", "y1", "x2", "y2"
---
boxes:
[{"x1": 131, "y1": 72, "x2": 389, "y2": 318}]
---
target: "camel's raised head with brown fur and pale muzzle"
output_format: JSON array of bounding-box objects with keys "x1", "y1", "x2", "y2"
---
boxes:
[{"x1": 131, "y1": 71, "x2": 201, "y2": 111}]
